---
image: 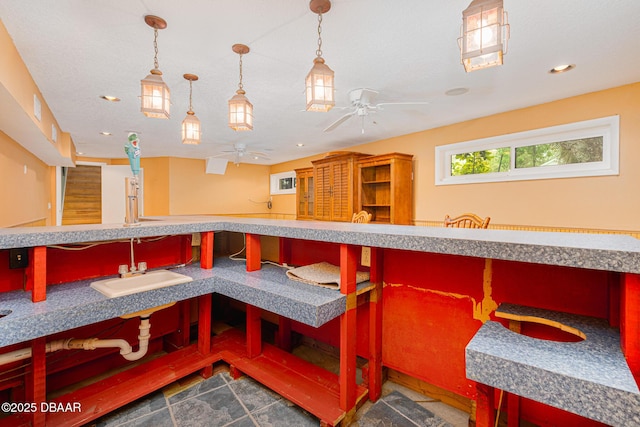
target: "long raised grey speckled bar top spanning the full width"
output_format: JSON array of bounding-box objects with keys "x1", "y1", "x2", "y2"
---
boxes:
[{"x1": 0, "y1": 215, "x2": 640, "y2": 273}]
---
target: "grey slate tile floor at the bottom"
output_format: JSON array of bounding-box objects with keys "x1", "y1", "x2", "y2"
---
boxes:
[{"x1": 89, "y1": 372, "x2": 467, "y2": 427}]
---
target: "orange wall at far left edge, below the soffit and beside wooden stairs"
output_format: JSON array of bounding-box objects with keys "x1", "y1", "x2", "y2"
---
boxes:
[{"x1": 0, "y1": 132, "x2": 55, "y2": 227}]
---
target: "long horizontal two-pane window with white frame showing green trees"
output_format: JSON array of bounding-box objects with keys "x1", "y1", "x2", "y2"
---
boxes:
[{"x1": 436, "y1": 116, "x2": 619, "y2": 185}]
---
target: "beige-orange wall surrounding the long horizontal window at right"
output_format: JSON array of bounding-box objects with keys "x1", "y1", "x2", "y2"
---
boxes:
[{"x1": 274, "y1": 83, "x2": 640, "y2": 231}]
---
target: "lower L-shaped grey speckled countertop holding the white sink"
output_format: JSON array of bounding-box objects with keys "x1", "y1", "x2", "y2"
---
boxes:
[{"x1": 0, "y1": 258, "x2": 366, "y2": 347}]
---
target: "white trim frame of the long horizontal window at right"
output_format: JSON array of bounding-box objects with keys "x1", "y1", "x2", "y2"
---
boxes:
[{"x1": 435, "y1": 116, "x2": 620, "y2": 185}]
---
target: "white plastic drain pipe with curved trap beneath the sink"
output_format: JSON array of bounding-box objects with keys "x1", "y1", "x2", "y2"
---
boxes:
[{"x1": 0, "y1": 316, "x2": 151, "y2": 366}]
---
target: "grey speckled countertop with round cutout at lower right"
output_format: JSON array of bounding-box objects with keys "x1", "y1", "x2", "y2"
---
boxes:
[{"x1": 466, "y1": 304, "x2": 640, "y2": 426}]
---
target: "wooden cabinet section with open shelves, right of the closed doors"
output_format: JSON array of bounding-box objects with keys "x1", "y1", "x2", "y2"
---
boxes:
[{"x1": 356, "y1": 153, "x2": 413, "y2": 225}]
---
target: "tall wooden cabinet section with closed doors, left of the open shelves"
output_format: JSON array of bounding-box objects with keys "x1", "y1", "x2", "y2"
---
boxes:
[{"x1": 311, "y1": 152, "x2": 368, "y2": 221}]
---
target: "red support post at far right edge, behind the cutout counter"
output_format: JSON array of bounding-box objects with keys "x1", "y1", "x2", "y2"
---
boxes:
[{"x1": 620, "y1": 273, "x2": 640, "y2": 381}]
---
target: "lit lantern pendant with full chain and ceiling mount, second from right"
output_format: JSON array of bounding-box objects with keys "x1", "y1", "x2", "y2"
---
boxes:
[{"x1": 305, "y1": 0, "x2": 336, "y2": 111}]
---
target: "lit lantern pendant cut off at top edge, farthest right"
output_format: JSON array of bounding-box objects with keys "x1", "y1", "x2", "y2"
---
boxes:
[{"x1": 458, "y1": 0, "x2": 509, "y2": 72}]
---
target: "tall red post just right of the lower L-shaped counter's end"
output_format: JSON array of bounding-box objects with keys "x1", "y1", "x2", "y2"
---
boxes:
[{"x1": 369, "y1": 248, "x2": 383, "y2": 402}]
